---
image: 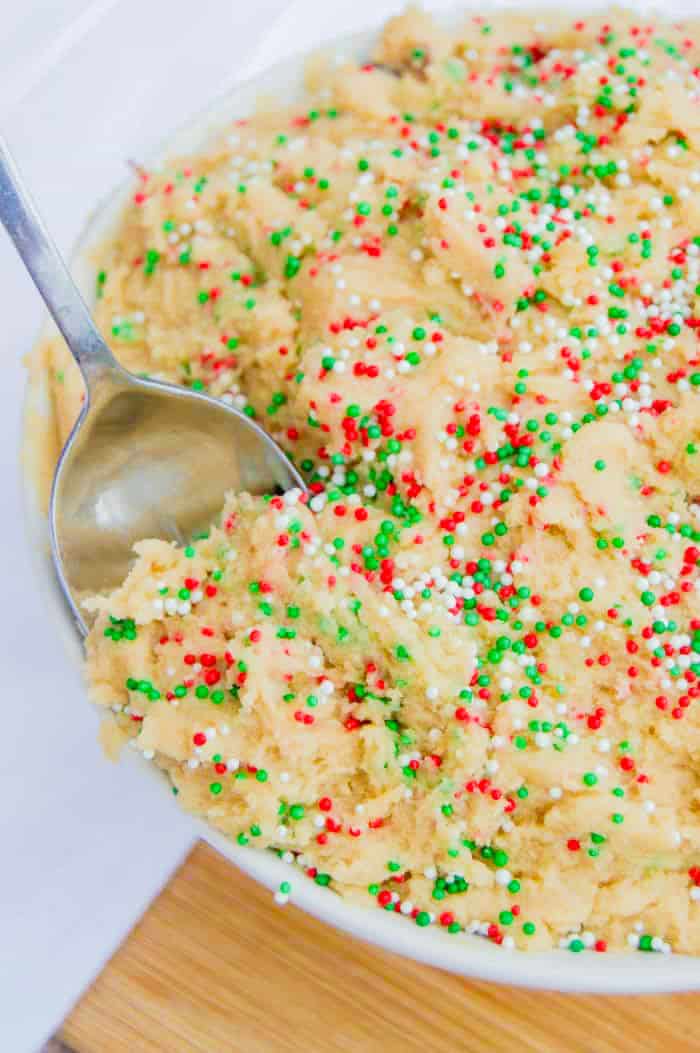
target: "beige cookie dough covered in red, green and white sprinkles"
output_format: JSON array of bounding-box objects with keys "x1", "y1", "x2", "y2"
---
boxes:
[{"x1": 52, "y1": 11, "x2": 700, "y2": 953}]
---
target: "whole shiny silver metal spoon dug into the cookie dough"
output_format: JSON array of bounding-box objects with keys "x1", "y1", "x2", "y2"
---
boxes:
[{"x1": 0, "y1": 137, "x2": 305, "y2": 635}]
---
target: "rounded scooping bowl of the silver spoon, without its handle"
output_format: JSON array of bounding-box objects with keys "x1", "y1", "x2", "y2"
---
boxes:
[{"x1": 48, "y1": 369, "x2": 303, "y2": 633}]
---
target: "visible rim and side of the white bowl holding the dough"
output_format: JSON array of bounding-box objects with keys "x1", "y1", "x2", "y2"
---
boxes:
[{"x1": 24, "y1": 10, "x2": 700, "y2": 994}]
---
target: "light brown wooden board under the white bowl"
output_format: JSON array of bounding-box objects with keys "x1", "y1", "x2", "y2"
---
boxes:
[{"x1": 62, "y1": 845, "x2": 700, "y2": 1053}]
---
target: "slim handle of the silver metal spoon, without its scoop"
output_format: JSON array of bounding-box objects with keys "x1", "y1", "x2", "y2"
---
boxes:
[{"x1": 0, "y1": 136, "x2": 119, "y2": 386}]
